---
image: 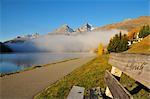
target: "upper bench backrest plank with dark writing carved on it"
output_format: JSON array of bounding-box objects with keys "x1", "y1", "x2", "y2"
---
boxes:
[{"x1": 109, "y1": 53, "x2": 150, "y2": 89}]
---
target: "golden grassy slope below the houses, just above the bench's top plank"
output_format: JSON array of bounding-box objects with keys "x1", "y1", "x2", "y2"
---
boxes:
[{"x1": 127, "y1": 35, "x2": 150, "y2": 53}]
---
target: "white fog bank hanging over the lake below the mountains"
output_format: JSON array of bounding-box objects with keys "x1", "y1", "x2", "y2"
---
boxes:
[{"x1": 7, "y1": 29, "x2": 127, "y2": 52}]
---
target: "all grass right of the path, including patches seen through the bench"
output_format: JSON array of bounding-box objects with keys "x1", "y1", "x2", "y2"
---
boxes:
[{"x1": 34, "y1": 55, "x2": 149, "y2": 99}]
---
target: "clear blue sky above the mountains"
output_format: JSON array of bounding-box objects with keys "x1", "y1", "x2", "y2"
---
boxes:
[{"x1": 0, "y1": 0, "x2": 149, "y2": 41}]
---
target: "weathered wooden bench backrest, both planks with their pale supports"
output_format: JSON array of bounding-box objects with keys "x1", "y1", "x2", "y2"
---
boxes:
[{"x1": 105, "y1": 53, "x2": 150, "y2": 99}]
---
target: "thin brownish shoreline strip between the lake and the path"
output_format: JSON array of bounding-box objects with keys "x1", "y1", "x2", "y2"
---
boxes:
[{"x1": 0, "y1": 58, "x2": 79, "y2": 78}]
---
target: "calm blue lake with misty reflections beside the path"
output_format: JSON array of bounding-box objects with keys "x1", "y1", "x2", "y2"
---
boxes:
[{"x1": 0, "y1": 53, "x2": 94, "y2": 73}]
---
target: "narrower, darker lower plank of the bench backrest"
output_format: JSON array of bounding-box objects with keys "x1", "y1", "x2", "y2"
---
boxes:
[{"x1": 105, "y1": 71, "x2": 133, "y2": 99}]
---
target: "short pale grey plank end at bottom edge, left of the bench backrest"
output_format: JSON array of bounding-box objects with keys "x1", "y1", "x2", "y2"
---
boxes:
[{"x1": 67, "y1": 86, "x2": 85, "y2": 99}]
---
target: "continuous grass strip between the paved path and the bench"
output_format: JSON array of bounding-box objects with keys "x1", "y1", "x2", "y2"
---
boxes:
[{"x1": 36, "y1": 55, "x2": 111, "y2": 99}]
